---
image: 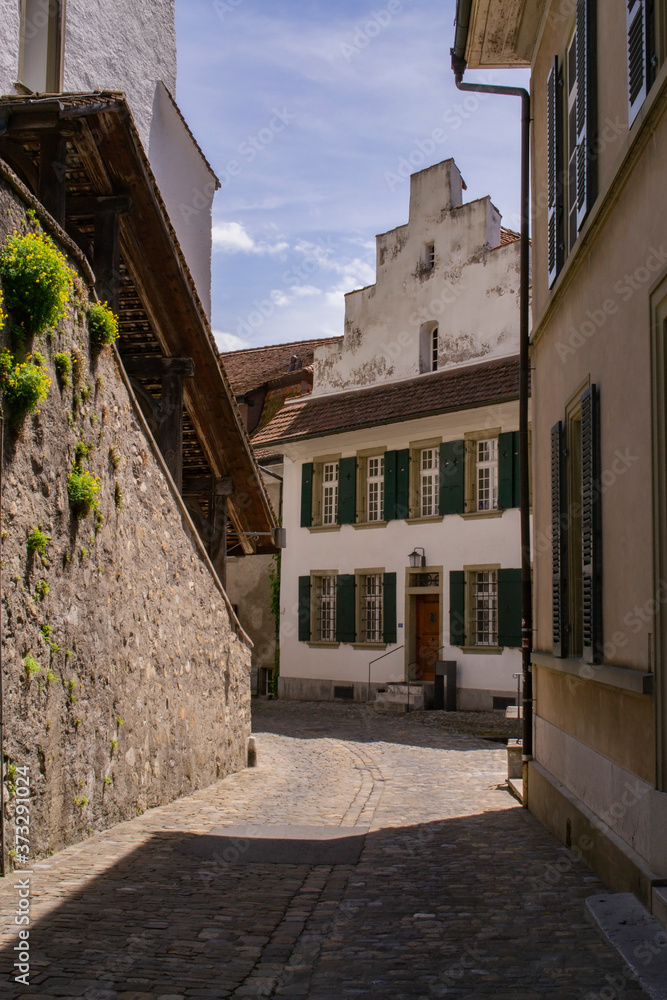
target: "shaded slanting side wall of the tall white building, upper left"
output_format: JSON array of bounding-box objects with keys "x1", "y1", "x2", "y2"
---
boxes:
[{"x1": 148, "y1": 82, "x2": 216, "y2": 317}]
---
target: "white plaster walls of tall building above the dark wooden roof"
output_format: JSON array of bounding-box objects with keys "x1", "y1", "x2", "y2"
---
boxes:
[{"x1": 0, "y1": 0, "x2": 217, "y2": 316}]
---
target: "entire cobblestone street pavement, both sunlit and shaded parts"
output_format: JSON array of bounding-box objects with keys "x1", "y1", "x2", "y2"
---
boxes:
[{"x1": 0, "y1": 702, "x2": 644, "y2": 1000}]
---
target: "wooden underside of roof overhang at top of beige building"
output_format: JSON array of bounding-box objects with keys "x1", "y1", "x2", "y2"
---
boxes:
[{"x1": 453, "y1": 0, "x2": 546, "y2": 69}]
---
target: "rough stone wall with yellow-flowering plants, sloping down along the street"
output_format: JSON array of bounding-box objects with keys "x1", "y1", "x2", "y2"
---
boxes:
[{"x1": 0, "y1": 172, "x2": 250, "y2": 855}]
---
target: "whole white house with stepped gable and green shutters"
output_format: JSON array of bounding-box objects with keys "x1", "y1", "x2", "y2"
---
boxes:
[{"x1": 253, "y1": 160, "x2": 532, "y2": 709}]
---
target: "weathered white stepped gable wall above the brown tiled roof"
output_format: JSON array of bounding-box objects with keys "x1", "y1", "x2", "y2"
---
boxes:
[{"x1": 313, "y1": 160, "x2": 520, "y2": 394}]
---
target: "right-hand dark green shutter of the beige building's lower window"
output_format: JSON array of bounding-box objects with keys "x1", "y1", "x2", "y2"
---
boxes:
[{"x1": 581, "y1": 385, "x2": 602, "y2": 663}]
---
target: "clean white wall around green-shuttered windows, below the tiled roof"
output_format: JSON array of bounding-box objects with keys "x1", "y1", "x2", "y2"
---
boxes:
[{"x1": 280, "y1": 403, "x2": 521, "y2": 696}]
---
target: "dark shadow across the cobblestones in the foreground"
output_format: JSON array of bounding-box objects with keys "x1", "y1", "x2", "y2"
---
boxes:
[{"x1": 0, "y1": 808, "x2": 643, "y2": 1000}]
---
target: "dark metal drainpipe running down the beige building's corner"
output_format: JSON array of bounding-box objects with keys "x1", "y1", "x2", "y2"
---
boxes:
[{"x1": 451, "y1": 48, "x2": 533, "y2": 779}]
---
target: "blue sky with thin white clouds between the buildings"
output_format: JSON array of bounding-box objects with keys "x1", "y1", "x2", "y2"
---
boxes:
[{"x1": 176, "y1": 0, "x2": 528, "y2": 350}]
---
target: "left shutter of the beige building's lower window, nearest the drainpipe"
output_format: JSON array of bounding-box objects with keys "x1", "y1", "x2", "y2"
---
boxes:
[{"x1": 551, "y1": 422, "x2": 568, "y2": 656}]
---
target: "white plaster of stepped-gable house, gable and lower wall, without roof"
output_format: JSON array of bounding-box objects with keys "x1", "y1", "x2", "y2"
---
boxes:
[{"x1": 266, "y1": 160, "x2": 532, "y2": 710}]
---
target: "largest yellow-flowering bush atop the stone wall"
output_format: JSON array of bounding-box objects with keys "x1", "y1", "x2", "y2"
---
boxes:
[{"x1": 0, "y1": 231, "x2": 73, "y2": 336}]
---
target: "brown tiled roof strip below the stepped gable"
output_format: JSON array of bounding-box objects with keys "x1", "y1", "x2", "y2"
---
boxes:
[{"x1": 253, "y1": 356, "x2": 519, "y2": 447}]
